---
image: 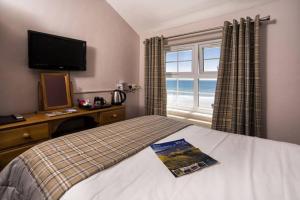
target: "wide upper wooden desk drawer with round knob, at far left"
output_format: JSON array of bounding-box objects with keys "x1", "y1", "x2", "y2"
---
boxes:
[{"x1": 0, "y1": 123, "x2": 49, "y2": 150}]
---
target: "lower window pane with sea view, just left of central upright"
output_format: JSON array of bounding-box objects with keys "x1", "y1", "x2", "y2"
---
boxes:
[{"x1": 177, "y1": 79, "x2": 194, "y2": 107}]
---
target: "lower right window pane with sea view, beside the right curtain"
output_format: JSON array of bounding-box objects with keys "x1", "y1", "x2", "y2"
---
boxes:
[{"x1": 198, "y1": 79, "x2": 217, "y2": 115}]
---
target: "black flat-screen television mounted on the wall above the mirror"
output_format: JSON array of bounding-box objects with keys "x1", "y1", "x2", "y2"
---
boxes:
[{"x1": 28, "y1": 30, "x2": 86, "y2": 71}]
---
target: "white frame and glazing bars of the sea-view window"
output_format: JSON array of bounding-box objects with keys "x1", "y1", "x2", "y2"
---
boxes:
[{"x1": 165, "y1": 39, "x2": 221, "y2": 121}]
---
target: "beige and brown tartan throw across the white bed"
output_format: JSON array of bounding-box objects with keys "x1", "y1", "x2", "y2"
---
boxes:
[{"x1": 19, "y1": 116, "x2": 189, "y2": 200}]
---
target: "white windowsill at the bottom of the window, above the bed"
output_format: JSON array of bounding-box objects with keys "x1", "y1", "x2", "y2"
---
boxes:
[{"x1": 167, "y1": 108, "x2": 211, "y2": 128}]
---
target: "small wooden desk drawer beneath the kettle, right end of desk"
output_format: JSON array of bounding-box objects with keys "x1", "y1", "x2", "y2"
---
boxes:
[{"x1": 100, "y1": 109, "x2": 125, "y2": 125}]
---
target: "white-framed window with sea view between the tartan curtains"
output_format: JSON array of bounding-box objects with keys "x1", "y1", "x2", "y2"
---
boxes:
[{"x1": 165, "y1": 40, "x2": 220, "y2": 120}]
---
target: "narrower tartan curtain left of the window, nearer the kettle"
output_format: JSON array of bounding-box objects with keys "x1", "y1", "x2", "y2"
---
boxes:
[{"x1": 145, "y1": 37, "x2": 167, "y2": 116}]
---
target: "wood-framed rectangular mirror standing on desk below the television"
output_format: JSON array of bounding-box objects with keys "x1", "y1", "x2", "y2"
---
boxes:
[{"x1": 41, "y1": 73, "x2": 72, "y2": 110}]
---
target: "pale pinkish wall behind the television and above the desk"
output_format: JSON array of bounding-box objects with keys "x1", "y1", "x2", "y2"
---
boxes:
[{"x1": 0, "y1": 0, "x2": 139, "y2": 117}]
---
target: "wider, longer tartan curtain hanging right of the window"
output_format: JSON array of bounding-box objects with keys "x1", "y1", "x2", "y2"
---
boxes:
[{"x1": 212, "y1": 15, "x2": 262, "y2": 137}]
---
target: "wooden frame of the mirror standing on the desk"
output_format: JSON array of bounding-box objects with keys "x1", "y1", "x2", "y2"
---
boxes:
[{"x1": 41, "y1": 73, "x2": 72, "y2": 110}]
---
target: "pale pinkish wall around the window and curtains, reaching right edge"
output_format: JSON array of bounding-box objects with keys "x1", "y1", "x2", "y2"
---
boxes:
[{"x1": 139, "y1": 0, "x2": 300, "y2": 144}]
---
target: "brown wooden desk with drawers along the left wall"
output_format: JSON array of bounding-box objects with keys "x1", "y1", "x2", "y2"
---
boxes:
[{"x1": 0, "y1": 106, "x2": 125, "y2": 170}]
